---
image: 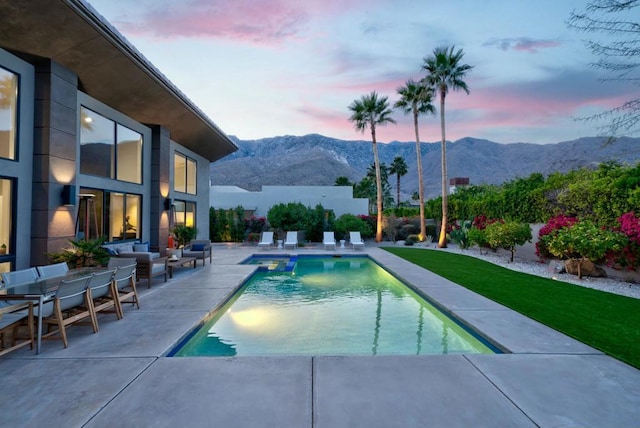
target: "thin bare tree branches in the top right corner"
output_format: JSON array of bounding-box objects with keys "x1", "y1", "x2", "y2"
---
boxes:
[{"x1": 567, "y1": 0, "x2": 640, "y2": 138}]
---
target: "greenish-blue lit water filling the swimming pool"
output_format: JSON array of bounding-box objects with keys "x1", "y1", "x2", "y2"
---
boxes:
[{"x1": 169, "y1": 257, "x2": 497, "y2": 356}]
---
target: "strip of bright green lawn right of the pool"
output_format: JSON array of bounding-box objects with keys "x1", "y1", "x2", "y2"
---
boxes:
[{"x1": 384, "y1": 247, "x2": 640, "y2": 368}]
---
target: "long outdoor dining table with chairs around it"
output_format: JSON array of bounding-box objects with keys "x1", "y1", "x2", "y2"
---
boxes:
[{"x1": 4, "y1": 267, "x2": 112, "y2": 354}]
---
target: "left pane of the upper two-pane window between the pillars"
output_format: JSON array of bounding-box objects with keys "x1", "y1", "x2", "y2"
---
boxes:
[{"x1": 80, "y1": 107, "x2": 116, "y2": 178}]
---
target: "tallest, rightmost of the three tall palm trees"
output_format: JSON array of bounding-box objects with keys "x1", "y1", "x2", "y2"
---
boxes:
[{"x1": 422, "y1": 46, "x2": 473, "y2": 248}]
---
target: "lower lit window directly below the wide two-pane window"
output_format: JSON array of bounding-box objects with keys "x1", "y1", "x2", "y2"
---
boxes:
[{"x1": 76, "y1": 189, "x2": 142, "y2": 241}]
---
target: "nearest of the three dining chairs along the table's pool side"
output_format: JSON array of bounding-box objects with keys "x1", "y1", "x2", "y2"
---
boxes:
[{"x1": 42, "y1": 276, "x2": 98, "y2": 348}]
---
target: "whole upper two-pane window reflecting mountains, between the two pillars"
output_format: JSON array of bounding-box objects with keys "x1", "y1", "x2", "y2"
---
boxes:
[{"x1": 80, "y1": 107, "x2": 142, "y2": 184}]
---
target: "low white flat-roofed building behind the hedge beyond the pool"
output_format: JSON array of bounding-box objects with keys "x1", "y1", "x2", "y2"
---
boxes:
[{"x1": 210, "y1": 186, "x2": 369, "y2": 217}]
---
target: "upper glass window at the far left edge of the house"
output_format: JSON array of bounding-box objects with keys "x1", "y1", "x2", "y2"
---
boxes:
[{"x1": 0, "y1": 67, "x2": 18, "y2": 159}]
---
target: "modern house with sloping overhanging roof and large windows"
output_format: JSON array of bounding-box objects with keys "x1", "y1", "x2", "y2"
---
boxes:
[{"x1": 0, "y1": 0, "x2": 237, "y2": 271}]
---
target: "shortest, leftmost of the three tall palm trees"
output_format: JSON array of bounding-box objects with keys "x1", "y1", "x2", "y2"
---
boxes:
[{"x1": 349, "y1": 91, "x2": 396, "y2": 242}]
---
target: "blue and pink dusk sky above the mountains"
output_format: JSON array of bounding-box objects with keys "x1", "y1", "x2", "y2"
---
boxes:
[{"x1": 88, "y1": 0, "x2": 638, "y2": 144}]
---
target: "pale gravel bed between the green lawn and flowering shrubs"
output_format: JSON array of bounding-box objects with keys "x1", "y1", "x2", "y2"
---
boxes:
[{"x1": 410, "y1": 244, "x2": 640, "y2": 299}]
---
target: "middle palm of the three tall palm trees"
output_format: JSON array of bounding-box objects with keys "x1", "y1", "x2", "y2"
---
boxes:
[{"x1": 394, "y1": 79, "x2": 436, "y2": 237}]
